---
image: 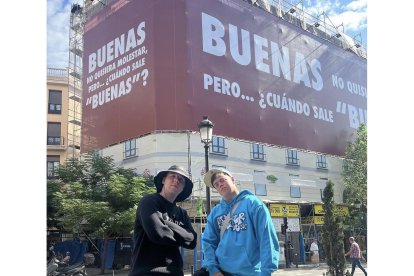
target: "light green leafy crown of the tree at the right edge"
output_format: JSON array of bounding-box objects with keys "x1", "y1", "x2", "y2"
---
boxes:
[{"x1": 342, "y1": 124, "x2": 367, "y2": 206}]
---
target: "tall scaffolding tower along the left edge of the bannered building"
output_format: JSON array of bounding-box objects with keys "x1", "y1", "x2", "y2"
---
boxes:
[{"x1": 67, "y1": 4, "x2": 85, "y2": 159}]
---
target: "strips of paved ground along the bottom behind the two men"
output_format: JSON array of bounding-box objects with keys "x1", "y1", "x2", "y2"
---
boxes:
[{"x1": 86, "y1": 263, "x2": 368, "y2": 276}]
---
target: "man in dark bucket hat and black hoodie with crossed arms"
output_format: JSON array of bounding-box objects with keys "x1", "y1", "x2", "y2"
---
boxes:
[{"x1": 128, "y1": 165, "x2": 197, "y2": 276}]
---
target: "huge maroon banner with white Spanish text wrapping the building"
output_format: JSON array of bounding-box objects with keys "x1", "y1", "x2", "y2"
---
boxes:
[{"x1": 81, "y1": 0, "x2": 367, "y2": 155}]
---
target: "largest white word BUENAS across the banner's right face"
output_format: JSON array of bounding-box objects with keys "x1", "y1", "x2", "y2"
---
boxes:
[{"x1": 202, "y1": 13, "x2": 323, "y2": 91}]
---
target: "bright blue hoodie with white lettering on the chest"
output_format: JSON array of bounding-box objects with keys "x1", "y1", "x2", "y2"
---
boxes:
[{"x1": 202, "y1": 190, "x2": 279, "y2": 276}]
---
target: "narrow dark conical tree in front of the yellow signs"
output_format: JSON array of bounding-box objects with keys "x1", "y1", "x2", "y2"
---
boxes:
[{"x1": 322, "y1": 180, "x2": 346, "y2": 276}]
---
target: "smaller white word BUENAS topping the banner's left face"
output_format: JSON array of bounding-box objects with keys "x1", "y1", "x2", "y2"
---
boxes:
[{"x1": 88, "y1": 21, "x2": 145, "y2": 74}]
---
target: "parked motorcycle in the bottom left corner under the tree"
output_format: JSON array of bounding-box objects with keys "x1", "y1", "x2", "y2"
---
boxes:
[{"x1": 46, "y1": 250, "x2": 87, "y2": 276}]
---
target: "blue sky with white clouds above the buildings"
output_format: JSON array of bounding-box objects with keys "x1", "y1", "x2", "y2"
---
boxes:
[{"x1": 47, "y1": 0, "x2": 367, "y2": 68}]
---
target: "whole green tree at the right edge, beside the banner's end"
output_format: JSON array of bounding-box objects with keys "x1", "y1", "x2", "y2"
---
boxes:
[{"x1": 342, "y1": 124, "x2": 367, "y2": 235}]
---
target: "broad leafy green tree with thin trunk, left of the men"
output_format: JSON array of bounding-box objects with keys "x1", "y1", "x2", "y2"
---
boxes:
[{"x1": 48, "y1": 153, "x2": 155, "y2": 274}]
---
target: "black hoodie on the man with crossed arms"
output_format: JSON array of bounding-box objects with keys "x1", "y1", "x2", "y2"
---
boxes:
[{"x1": 128, "y1": 194, "x2": 197, "y2": 276}]
